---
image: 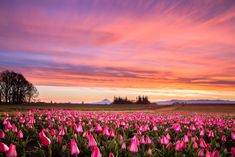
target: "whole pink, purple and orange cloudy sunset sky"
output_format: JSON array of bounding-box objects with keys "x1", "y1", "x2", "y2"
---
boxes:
[{"x1": 0, "y1": 0, "x2": 235, "y2": 102}]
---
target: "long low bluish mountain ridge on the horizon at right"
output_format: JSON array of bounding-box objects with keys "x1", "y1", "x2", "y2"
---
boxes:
[{"x1": 155, "y1": 100, "x2": 235, "y2": 105}]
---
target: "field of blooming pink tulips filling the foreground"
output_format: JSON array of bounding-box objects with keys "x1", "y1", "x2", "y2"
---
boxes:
[{"x1": 0, "y1": 110, "x2": 235, "y2": 157}]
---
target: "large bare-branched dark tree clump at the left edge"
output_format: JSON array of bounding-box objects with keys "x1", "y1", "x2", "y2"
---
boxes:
[{"x1": 0, "y1": 70, "x2": 38, "y2": 104}]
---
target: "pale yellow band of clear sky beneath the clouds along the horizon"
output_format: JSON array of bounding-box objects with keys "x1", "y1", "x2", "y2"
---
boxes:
[{"x1": 37, "y1": 86, "x2": 235, "y2": 103}]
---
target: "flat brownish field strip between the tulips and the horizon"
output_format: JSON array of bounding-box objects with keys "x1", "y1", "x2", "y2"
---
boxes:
[{"x1": 0, "y1": 103, "x2": 235, "y2": 114}]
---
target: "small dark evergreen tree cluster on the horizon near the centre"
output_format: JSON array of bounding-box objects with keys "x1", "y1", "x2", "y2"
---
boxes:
[{"x1": 112, "y1": 96, "x2": 150, "y2": 104}]
